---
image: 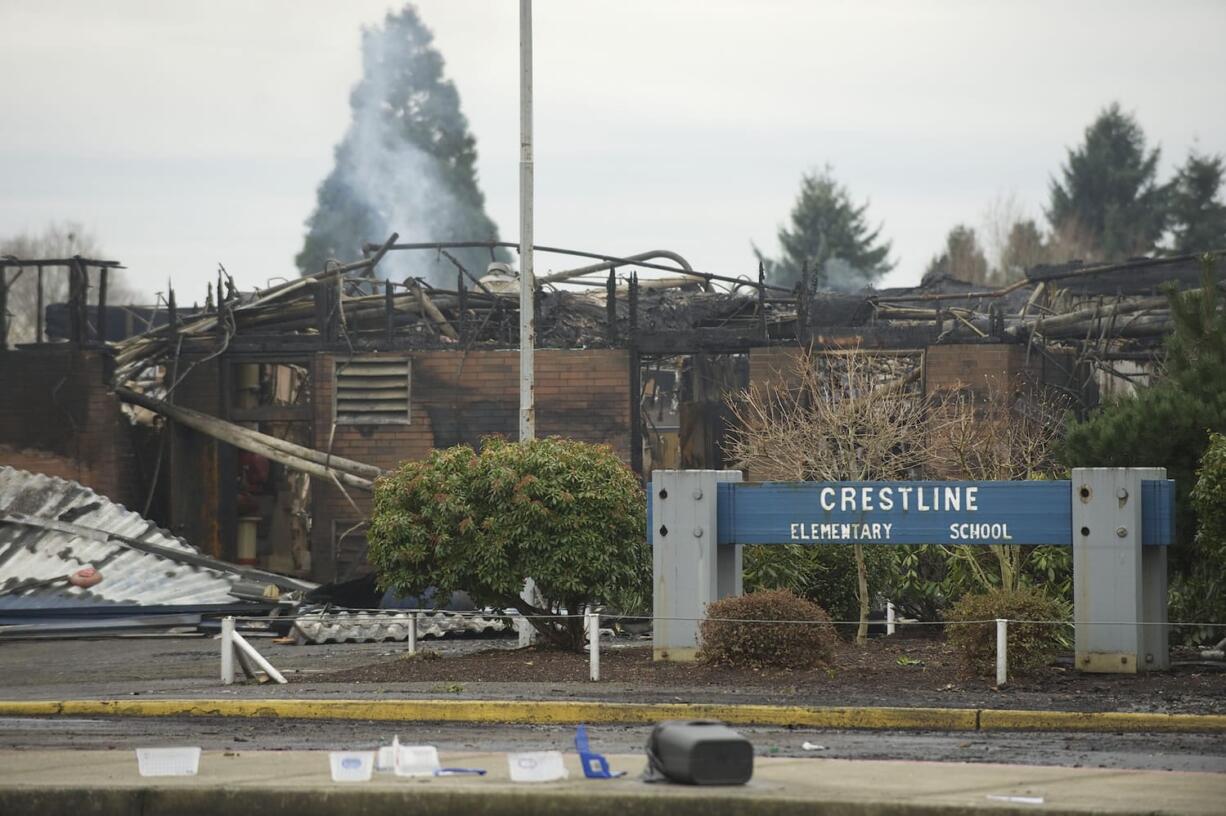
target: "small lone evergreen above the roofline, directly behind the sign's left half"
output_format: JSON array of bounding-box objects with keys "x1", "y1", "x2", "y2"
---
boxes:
[{"x1": 758, "y1": 168, "x2": 894, "y2": 289}]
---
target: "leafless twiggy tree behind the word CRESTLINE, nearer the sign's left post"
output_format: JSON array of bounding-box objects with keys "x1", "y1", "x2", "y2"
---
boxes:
[{"x1": 727, "y1": 349, "x2": 929, "y2": 643}]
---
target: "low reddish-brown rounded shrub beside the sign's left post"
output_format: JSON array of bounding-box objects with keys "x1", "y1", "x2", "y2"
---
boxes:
[{"x1": 699, "y1": 589, "x2": 839, "y2": 669}]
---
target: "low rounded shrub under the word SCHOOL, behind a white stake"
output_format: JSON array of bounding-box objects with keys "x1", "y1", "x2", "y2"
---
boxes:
[{"x1": 945, "y1": 587, "x2": 1068, "y2": 676}]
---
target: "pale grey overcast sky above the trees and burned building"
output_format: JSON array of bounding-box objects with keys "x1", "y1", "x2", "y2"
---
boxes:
[{"x1": 0, "y1": 0, "x2": 1226, "y2": 301}]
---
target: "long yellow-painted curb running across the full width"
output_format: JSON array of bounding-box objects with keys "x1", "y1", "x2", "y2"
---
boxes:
[{"x1": 0, "y1": 698, "x2": 1226, "y2": 733}]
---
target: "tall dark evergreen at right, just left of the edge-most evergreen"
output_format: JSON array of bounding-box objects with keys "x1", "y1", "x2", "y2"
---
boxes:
[{"x1": 1047, "y1": 103, "x2": 1166, "y2": 261}]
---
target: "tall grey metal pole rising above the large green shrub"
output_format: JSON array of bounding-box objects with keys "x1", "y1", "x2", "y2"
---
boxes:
[{"x1": 520, "y1": 0, "x2": 536, "y2": 442}]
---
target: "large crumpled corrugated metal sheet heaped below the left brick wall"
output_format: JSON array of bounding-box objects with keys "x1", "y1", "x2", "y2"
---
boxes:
[{"x1": 0, "y1": 467, "x2": 251, "y2": 609}]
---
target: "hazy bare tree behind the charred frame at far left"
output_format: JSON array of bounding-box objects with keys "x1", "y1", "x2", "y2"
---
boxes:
[{"x1": 0, "y1": 222, "x2": 135, "y2": 343}]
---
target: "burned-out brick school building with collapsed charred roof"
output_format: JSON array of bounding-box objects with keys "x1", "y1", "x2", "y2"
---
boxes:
[{"x1": 0, "y1": 240, "x2": 1216, "y2": 581}]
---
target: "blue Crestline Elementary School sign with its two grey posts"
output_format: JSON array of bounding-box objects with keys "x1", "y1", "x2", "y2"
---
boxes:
[{"x1": 647, "y1": 468, "x2": 1175, "y2": 673}]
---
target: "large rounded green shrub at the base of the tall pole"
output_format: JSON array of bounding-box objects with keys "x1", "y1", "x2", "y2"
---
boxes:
[{"x1": 367, "y1": 437, "x2": 651, "y2": 649}]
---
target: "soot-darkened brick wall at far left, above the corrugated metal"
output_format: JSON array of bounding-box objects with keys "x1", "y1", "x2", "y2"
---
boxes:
[{"x1": 0, "y1": 344, "x2": 143, "y2": 510}]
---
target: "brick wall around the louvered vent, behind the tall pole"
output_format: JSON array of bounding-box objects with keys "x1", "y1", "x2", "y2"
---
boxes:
[{"x1": 311, "y1": 349, "x2": 630, "y2": 580}]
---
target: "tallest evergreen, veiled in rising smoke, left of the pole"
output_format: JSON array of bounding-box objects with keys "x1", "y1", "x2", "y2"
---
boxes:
[{"x1": 295, "y1": 5, "x2": 506, "y2": 281}]
